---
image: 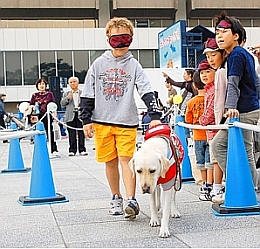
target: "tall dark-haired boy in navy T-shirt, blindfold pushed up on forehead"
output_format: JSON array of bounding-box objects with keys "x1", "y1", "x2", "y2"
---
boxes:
[{"x1": 212, "y1": 12, "x2": 259, "y2": 190}]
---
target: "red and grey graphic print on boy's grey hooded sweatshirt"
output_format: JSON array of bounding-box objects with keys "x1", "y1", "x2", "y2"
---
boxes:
[{"x1": 99, "y1": 68, "x2": 132, "y2": 101}]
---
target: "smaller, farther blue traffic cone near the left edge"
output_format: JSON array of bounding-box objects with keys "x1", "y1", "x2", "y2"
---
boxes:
[{"x1": 1, "y1": 122, "x2": 31, "y2": 173}]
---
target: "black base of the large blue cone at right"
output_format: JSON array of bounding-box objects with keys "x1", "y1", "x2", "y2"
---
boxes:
[{"x1": 212, "y1": 204, "x2": 260, "y2": 216}]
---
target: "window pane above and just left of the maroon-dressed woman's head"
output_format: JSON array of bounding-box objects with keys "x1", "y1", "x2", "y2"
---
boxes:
[{"x1": 23, "y1": 51, "x2": 39, "y2": 85}]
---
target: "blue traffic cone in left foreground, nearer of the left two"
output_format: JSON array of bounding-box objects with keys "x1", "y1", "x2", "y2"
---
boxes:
[{"x1": 18, "y1": 122, "x2": 68, "y2": 205}]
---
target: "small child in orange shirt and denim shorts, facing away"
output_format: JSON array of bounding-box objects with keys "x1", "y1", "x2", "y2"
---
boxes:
[{"x1": 185, "y1": 72, "x2": 210, "y2": 194}]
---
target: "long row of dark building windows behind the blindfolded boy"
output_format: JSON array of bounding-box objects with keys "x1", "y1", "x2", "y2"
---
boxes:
[{"x1": 0, "y1": 49, "x2": 159, "y2": 86}]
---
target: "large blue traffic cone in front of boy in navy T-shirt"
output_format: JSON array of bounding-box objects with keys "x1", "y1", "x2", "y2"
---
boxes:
[{"x1": 212, "y1": 118, "x2": 260, "y2": 216}]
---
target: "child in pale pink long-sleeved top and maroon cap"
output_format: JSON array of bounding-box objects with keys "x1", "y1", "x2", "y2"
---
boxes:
[{"x1": 203, "y1": 38, "x2": 227, "y2": 203}]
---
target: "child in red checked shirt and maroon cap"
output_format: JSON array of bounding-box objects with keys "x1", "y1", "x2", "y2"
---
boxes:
[{"x1": 198, "y1": 60, "x2": 217, "y2": 201}]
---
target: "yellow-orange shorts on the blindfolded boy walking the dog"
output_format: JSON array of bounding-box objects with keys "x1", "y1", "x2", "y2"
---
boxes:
[{"x1": 93, "y1": 123, "x2": 137, "y2": 163}]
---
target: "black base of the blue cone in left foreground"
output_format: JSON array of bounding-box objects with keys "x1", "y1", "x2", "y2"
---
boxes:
[{"x1": 18, "y1": 193, "x2": 69, "y2": 206}]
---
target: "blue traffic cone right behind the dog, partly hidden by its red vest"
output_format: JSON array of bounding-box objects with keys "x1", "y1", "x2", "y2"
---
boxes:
[{"x1": 174, "y1": 115, "x2": 194, "y2": 182}]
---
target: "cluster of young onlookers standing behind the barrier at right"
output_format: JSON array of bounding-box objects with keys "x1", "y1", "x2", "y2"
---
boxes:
[{"x1": 181, "y1": 12, "x2": 260, "y2": 203}]
